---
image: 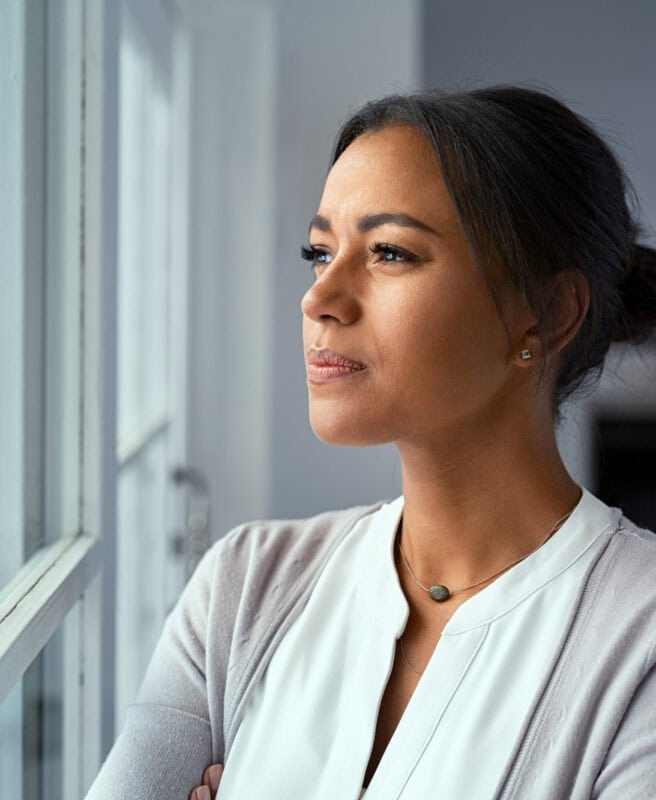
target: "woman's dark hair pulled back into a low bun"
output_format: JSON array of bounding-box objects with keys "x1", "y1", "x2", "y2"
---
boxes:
[{"x1": 332, "y1": 86, "x2": 656, "y2": 409}]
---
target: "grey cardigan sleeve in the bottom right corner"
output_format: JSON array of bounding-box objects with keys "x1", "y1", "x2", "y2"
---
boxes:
[{"x1": 591, "y1": 666, "x2": 656, "y2": 800}]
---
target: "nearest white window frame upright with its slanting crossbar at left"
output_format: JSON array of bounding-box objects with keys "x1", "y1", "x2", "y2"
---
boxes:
[{"x1": 0, "y1": 0, "x2": 120, "y2": 780}]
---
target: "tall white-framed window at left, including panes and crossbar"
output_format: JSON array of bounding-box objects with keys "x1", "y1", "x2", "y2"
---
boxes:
[{"x1": 0, "y1": 0, "x2": 188, "y2": 800}]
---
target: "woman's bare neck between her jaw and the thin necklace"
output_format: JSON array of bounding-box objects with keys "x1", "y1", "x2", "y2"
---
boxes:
[{"x1": 398, "y1": 410, "x2": 580, "y2": 588}]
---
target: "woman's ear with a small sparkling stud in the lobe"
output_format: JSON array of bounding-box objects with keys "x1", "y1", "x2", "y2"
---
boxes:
[{"x1": 515, "y1": 270, "x2": 590, "y2": 367}]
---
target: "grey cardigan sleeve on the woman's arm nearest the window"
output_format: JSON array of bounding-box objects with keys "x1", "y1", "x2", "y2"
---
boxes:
[{"x1": 86, "y1": 545, "x2": 223, "y2": 800}]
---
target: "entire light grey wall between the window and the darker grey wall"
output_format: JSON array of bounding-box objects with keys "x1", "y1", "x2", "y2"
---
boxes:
[{"x1": 184, "y1": 0, "x2": 420, "y2": 537}]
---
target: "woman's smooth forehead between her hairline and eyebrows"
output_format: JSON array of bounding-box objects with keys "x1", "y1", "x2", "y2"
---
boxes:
[{"x1": 319, "y1": 125, "x2": 460, "y2": 229}]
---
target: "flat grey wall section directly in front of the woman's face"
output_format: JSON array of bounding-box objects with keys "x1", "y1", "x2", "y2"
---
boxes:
[{"x1": 271, "y1": 0, "x2": 420, "y2": 516}]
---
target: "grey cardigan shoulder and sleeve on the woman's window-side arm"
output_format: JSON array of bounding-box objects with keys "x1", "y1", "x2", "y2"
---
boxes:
[{"x1": 87, "y1": 505, "x2": 366, "y2": 800}]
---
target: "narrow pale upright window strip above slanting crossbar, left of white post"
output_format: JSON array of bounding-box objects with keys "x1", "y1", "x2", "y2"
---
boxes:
[{"x1": 41, "y1": 0, "x2": 84, "y2": 542}]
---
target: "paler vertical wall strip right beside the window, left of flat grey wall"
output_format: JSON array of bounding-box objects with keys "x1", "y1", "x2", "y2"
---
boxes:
[{"x1": 187, "y1": 0, "x2": 277, "y2": 537}]
